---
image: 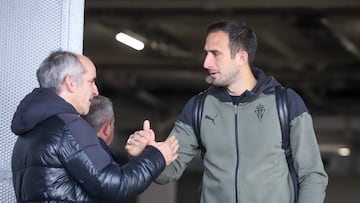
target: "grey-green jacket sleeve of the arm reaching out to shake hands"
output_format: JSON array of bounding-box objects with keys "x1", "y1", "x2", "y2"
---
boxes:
[{"x1": 155, "y1": 96, "x2": 200, "y2": 184}]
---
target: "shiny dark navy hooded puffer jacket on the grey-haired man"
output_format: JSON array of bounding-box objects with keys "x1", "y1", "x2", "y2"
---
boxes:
[{"x1": 11, "y1": 88, "x2": 165, "y2": 202}]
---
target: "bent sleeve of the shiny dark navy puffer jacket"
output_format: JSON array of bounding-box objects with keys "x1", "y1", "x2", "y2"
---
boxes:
[{"x1": 60, "y1": 119, "x2": 166, "y2": 200}]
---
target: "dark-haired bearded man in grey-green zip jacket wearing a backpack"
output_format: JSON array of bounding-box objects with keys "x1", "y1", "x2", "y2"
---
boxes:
[{"x1": 156, "y1": 21, "x2": 328, "y2": 203}]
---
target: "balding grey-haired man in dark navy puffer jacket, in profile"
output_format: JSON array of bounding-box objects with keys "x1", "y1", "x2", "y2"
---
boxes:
[{"x1": 11, "y1": 51, "x2": 178, "y2": 202}]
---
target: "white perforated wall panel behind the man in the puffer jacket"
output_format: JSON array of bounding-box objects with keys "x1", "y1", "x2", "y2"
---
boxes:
[{"x1": 0, "y1": 0, "x2": 84, "y2": 203}]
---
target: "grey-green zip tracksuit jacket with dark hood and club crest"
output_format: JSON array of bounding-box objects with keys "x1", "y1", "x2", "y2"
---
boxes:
[{"x1": 157, "y1": 68, "x2": 327, "y2": 203}]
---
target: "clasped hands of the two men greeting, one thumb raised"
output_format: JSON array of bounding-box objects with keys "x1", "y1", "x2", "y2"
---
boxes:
[{"x1": 125, "y1": 120, "x2": 179, "y2": 165}]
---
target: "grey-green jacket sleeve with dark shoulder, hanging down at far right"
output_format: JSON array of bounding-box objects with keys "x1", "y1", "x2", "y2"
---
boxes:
[{"x1": 288, "y1": 90, "x2": 328, "y2": 203}]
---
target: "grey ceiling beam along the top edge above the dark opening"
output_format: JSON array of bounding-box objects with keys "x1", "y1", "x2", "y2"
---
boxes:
[{"x1": 86, "y1": 0, "x2": 360, "y2": 10}]
